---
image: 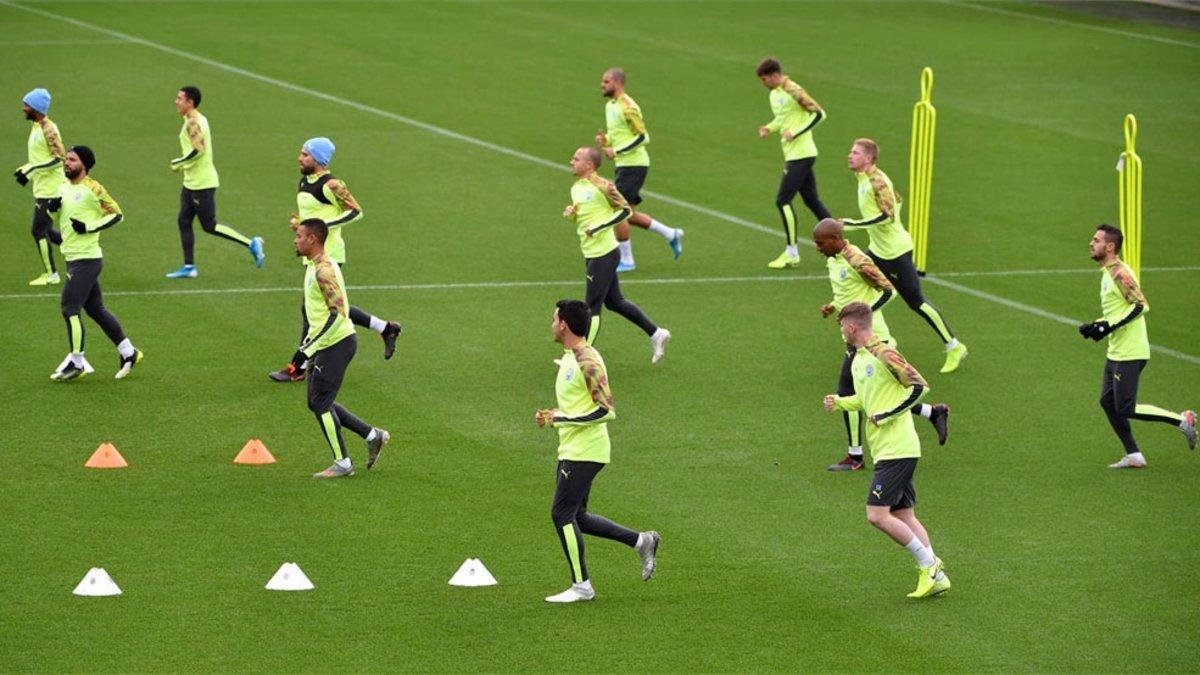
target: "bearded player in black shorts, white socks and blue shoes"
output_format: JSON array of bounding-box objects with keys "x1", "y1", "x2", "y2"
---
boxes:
[{"x1": 596, "y1": 68, "x2": 683, "y2": 271}]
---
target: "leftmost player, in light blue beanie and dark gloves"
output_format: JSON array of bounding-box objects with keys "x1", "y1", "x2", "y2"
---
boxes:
[{"x1": 12, "y1": 89, "x2": 67, "y2": 286}]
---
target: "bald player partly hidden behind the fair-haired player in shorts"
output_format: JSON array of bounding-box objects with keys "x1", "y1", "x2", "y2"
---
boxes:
[{"x1": 812, "y1": 219, "x2": 950, "y2": 471}]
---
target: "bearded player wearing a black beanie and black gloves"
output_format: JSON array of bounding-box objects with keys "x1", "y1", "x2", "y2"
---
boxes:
[{"x1": 50, "y1": 145, "x2": 143, "y2": 382}]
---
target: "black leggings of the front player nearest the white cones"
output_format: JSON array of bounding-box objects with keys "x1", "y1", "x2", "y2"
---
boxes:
[{"x1": 550, "y1": 459, "x2": 637, "y2": 584}]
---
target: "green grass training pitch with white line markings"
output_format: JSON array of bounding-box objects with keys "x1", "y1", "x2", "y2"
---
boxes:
[{"x1": 0, "y1": 0, "x2": 1200, "y2": 671}]
